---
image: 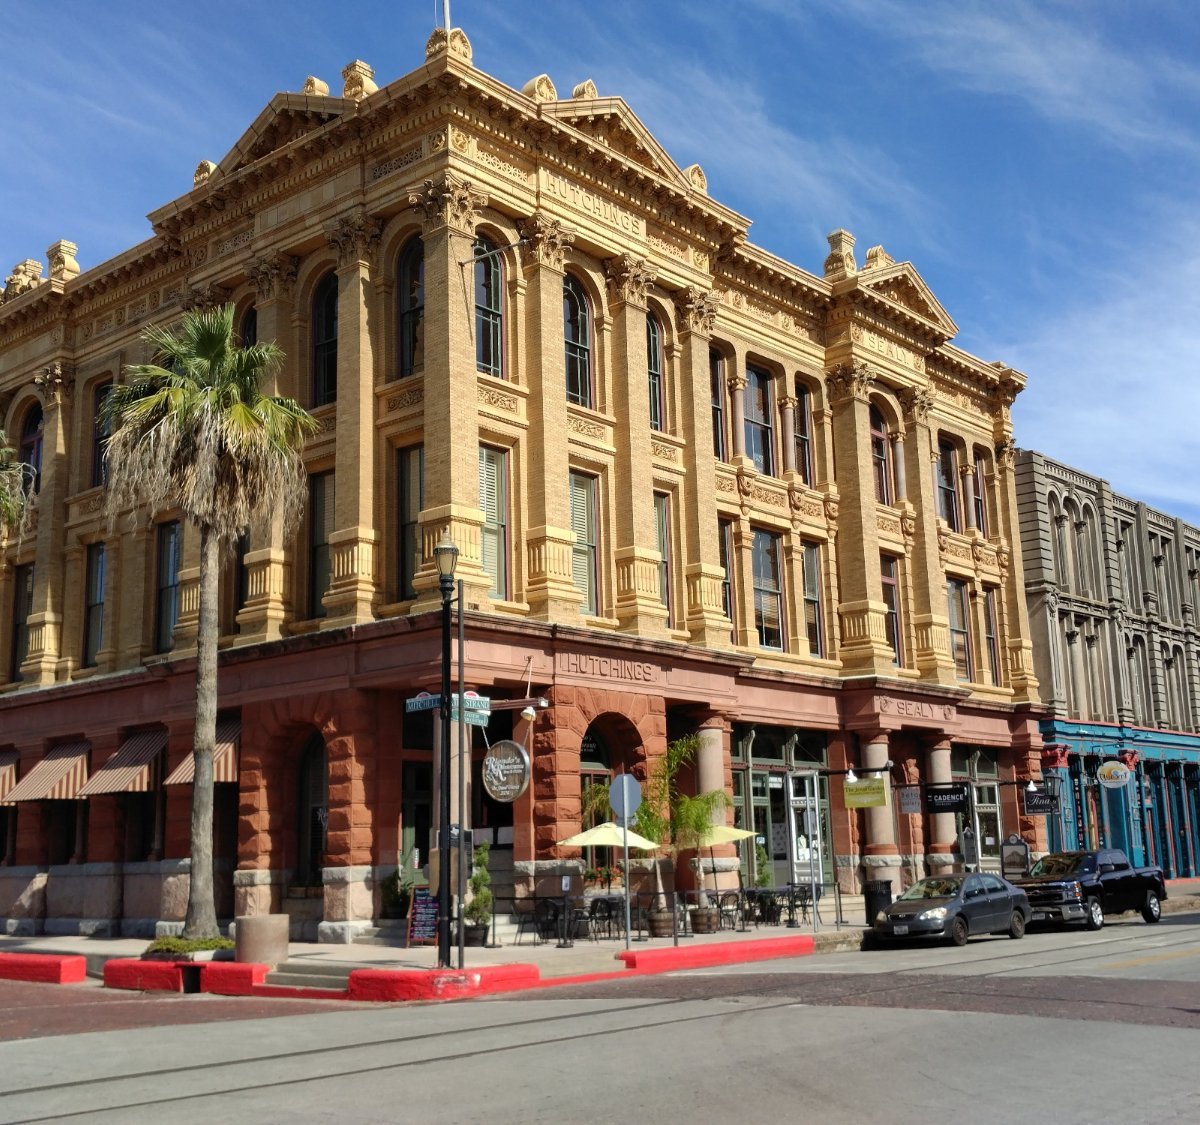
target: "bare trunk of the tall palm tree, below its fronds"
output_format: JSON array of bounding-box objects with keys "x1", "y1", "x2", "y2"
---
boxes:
[{"x1": 184, "y1": 528, "x2": 221, "y2": 938}]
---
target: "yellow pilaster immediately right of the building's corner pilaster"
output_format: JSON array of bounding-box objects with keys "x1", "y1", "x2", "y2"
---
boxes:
[{"x1": 520, "y1": 212, "x2": 583, "y2": 624}]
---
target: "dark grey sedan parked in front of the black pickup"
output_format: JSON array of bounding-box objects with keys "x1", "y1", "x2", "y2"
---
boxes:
[{"x1": 872, "y1": 873, "x2": 1032, "y2": 945}]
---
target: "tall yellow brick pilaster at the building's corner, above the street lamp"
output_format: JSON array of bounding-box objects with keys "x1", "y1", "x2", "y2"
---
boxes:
[{"x1": 408, "y1": 173, "x2": 492, "y2": 609}]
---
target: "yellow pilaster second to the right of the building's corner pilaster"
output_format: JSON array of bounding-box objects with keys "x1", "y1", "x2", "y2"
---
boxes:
[{"x1": 605, "y1": 254, "x2": 667, "y2": 639}]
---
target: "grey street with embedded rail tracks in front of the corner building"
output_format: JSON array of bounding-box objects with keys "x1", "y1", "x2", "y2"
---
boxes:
[{"x1": 0, "y1": 915, "x2": 1200, "y2": 1125}]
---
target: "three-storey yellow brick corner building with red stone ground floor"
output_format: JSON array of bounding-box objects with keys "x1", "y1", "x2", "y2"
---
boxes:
[{"x1": 0, "y1": 29, "x2": 1040, "y2": 940}]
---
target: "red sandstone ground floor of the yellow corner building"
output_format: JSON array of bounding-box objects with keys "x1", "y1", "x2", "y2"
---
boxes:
[{"x1": 0, "y1": 614, "x2": 1046, "y2": 941}]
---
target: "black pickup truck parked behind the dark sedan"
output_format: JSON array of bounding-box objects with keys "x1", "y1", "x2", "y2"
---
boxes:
[{"x1": 1009, "y1": 848, "x2": 1166, "y2": 930}]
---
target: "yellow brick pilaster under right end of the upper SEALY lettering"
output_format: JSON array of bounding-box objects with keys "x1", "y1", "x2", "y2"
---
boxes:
[{"x1": 900, "y1": 389, "x2": 958, "y2": 684}]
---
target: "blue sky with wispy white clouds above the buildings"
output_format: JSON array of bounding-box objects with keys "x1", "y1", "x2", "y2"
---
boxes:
[{"x1": 0, "y1": 0, "x2": 1200, "y2": 525}]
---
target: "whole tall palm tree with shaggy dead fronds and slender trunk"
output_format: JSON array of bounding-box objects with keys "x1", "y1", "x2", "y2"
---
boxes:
[{"x1": 102, "y1": 305, "x2": 317, "y2": 938}]
